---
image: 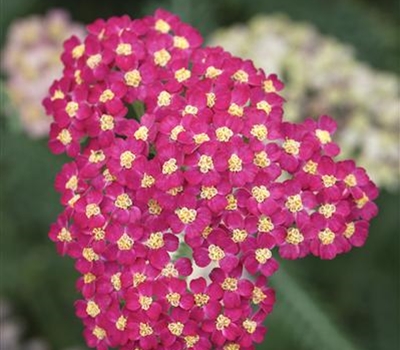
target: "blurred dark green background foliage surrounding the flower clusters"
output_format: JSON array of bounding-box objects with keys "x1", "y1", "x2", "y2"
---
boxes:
[{"x1": 0, "y1": 0, "x2": 400, "y2": 350}]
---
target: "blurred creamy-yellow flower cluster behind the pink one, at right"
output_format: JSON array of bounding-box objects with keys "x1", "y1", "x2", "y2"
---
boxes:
[{"x1": 210, "y1": 15, "x2": 400, "y2": 189}]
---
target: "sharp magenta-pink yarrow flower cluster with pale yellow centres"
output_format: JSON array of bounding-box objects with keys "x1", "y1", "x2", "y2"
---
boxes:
[{"x1": 44, "y1": 10, "x2": 378, "y2": 350}]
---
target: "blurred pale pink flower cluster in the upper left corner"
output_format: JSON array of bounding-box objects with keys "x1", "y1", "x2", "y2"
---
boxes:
[{"x1": 2, "y1": 10, "x2": 84, "y2": 138}]
